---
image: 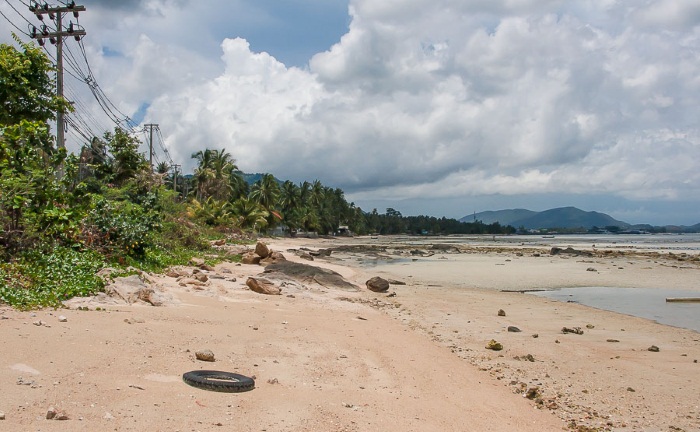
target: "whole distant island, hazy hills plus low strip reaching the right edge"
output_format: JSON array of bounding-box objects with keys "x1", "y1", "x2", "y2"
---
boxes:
[{"x1": 459, "y1": 207, "x2": 700, "y2": 233}]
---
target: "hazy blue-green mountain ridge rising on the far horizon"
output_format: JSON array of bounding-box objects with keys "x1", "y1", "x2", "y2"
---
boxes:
[{"x1": 460, "y1": 207, "x2": 630, "y2": 229}]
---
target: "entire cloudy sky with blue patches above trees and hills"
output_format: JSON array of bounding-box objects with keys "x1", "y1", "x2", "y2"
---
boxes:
[{"x1": 0, "y1": 0, "x2": 700, "y2": 225}]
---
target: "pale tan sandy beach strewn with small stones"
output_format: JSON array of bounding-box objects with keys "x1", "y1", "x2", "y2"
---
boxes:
[{"x1": 0, "y1": 238, "x2": 700, "y2": 432}]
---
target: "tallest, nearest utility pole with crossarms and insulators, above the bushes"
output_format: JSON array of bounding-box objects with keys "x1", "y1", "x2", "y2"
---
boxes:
[{"x1": 29, "y1": 1, "x2": 86, "y2": 154}]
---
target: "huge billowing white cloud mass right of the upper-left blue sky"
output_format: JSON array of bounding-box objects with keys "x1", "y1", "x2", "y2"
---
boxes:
[{"x1": 139, "y1": 0, "x2": 700, "y2": 211}]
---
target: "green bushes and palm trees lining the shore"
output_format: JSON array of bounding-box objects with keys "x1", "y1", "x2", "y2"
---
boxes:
[{"x1": 0, "y1": 37, "x2": 509, "y2": 309}]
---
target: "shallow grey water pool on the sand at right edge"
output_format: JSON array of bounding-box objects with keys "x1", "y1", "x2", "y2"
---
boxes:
[{"x1": 530, "y1": 287, "x2": 700, "y2": 332}]
